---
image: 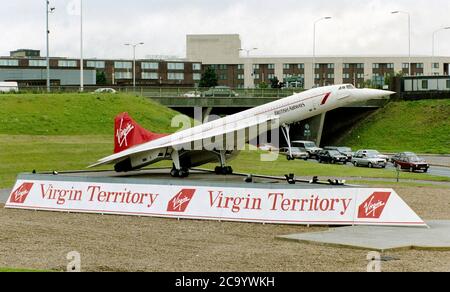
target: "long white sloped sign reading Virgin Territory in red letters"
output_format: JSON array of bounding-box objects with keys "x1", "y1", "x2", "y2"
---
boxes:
[{"x1": 6, "y1": 179, "x2": 426, "y2": 226}]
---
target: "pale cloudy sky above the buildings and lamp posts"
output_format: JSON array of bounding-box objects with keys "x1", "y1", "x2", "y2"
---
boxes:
[{"x1": 0, "y1": 0, "x2": 450, "y2": 58}]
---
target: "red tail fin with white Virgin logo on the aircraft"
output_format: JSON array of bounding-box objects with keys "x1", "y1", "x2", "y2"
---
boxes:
[{"x1": 114, "y1": 113, "x2": 167, "y2": 153}]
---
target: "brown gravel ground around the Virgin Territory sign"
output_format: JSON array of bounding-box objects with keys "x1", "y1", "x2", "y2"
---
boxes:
[{"x1": 0, "y1": 186, "x2": 450, "y2": 272}]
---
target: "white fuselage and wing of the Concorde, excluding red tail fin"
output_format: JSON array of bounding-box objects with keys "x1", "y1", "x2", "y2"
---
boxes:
[{"x1": 94, "y1": 85, "x2": 393, "y2": 169}]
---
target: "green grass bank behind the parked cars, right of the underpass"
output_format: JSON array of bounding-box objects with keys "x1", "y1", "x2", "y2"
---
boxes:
[{"x1": 341, "y1": 99, "x2": 450, "y2": 154}]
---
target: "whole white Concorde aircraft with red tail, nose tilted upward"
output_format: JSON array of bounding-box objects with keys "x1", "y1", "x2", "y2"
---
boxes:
[{"x1": 90, "y1": 84, "x2": 395, "y2": 177}]
